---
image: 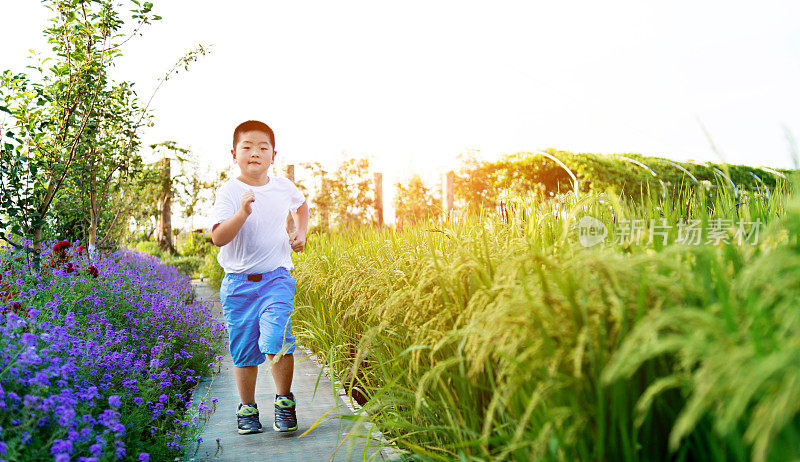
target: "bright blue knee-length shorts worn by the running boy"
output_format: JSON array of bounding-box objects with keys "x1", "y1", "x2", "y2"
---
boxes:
[{"x1": 219, "y1": 267, "x2": 295, "y2": 367}]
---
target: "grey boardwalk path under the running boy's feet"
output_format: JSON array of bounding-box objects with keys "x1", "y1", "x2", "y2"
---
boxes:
[{"x1": 186, "y1": 284, "x2": 384, "y2": 462}]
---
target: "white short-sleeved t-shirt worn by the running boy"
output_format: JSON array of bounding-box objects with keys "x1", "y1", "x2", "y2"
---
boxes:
[{"x1": 211, "y1": 176, "x2": 306, "y2": 274}]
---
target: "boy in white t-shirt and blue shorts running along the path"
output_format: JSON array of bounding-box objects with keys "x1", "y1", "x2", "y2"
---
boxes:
[{"x1": 211, "y1": 120, "x2": 308, "y2": 434}]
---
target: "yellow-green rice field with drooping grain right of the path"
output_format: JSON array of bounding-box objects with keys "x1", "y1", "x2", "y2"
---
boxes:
[{"x1": 293, "y1": 180, "x2": 800, "y2": 461}]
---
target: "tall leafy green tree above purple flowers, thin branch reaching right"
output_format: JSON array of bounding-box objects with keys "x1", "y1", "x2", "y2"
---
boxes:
[{"x1": 0, "y1": 0, "x2": 206, "y2": 260}]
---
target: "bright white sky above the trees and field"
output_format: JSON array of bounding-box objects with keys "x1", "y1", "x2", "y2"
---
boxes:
[{"x1": 0, "y1": 0, "x2": 800, "y2": 226}]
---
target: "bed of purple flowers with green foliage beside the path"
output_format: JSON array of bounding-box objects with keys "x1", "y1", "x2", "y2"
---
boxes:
[{"x1": 0, "y1": 241, "x2": 224, "y2": 461}]
